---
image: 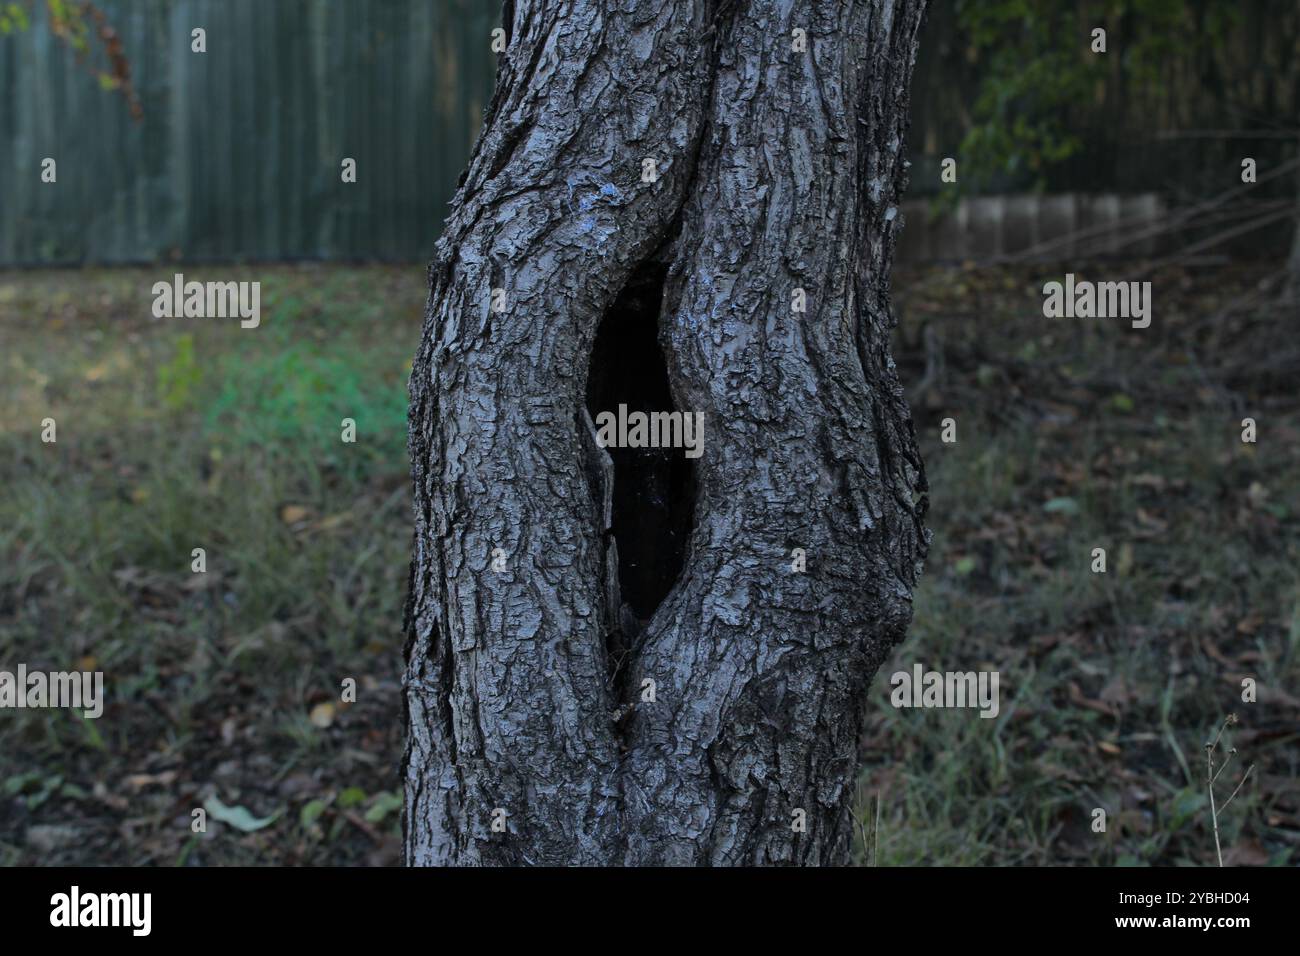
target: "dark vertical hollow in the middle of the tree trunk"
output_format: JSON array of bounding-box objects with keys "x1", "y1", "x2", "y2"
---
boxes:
[{"x1": 586, "y1": 263, "x2": 694, "y2": 637}]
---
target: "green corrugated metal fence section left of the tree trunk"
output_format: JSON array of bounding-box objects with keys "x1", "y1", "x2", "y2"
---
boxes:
[{"x1": 0, "y1": 0, "x2": 498, "y2": 265}]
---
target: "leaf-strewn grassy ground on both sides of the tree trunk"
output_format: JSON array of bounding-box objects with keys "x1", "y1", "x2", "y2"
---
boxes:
[{"x1": 0, "y1": 265, "x2": 1300, "y2": 865}]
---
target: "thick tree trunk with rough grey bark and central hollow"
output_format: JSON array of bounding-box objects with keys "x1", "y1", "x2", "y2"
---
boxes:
[{"x1": 404, "y1": 0, "x2": 928, "y2": 865}]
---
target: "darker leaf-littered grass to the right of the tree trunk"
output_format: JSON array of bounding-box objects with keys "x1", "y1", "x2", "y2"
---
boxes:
[{"x1": 859, "y1": 260, "x2": 1300, "y2": 865}]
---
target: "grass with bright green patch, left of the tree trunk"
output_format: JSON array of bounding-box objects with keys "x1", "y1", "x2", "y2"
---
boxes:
[{"x1": 0, "y1": 268, "x2": 423, "y2": 864}]
